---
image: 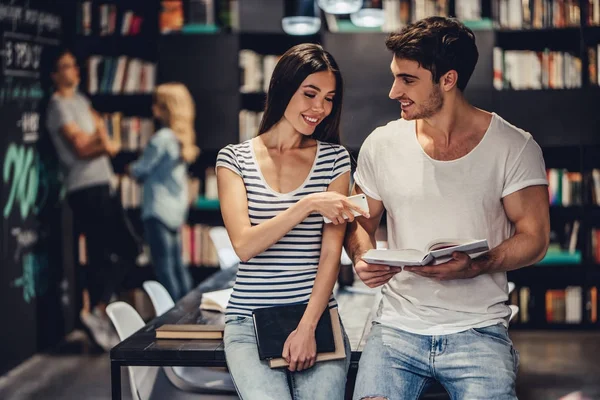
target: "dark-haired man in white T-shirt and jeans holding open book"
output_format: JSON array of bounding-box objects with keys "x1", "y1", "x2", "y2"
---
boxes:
[{"x1": 346, "y1": 17, "x2": 549, "y2": 400}]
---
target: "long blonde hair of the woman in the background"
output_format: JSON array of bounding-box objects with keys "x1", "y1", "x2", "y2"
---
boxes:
[{"x1": 154, "y1": 82, "x2": 200, "y2": 163}]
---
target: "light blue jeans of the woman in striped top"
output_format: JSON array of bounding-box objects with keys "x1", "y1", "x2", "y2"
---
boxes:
[{"x1": 223, "y1": 316, "x2": 350, "y2": 400}]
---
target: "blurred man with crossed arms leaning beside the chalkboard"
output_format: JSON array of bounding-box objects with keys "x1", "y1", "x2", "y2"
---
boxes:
[{"x1": 46, "y1": 49, "x2": 124, "y2": 350}]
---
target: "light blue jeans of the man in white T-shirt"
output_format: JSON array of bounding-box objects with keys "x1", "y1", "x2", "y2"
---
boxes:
[{"x1": 353, "y1": 323, "x2": 519, "y2": 400}]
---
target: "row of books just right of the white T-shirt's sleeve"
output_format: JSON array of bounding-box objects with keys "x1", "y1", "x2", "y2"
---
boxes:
[{"x1": 547, "y1": 168, "x2": 600, "y2": 207}]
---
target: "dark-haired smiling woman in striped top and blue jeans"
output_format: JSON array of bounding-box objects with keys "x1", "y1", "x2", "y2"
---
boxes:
[{"x1": 216, "y1": 44, "x2": 366, "y2": 400}]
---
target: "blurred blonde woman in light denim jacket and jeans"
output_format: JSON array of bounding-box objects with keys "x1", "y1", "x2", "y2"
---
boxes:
[{"x1": 130, "y1": 83, "x2": 199, "y2": 301}]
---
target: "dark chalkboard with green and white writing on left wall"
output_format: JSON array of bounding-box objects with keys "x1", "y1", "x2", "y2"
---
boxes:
[{"x1": 0, "y1": 0, "x2": 62, "y2": 373}]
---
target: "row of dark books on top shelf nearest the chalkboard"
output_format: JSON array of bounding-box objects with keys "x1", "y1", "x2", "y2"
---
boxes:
[{"x1": 75, "y1": 1, "x2": 144, "y2": 36}]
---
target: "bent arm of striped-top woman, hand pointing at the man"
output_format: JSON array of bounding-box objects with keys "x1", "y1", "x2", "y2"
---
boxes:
[{"x1": 217, "y1": 167, "x2": 363, "y2": 261}]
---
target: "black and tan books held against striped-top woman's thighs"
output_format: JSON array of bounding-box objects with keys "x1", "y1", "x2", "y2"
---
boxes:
[{"x1": 252, "y1": 304, "x2": 346, "y2": 368}]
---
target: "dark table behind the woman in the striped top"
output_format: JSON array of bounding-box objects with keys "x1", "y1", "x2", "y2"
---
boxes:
[{"x1": 110, "y1": 268, "x2": 375, "y2": 400}]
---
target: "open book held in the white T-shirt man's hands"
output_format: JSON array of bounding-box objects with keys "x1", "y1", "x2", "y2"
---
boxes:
[{"x1": 363, "y1": 239, "x2": 490, "y2": 267}]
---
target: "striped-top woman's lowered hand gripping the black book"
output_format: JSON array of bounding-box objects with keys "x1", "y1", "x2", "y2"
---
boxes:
[{"x1": 282, "y1": 326, "x2": 317, "y2": 372}]
